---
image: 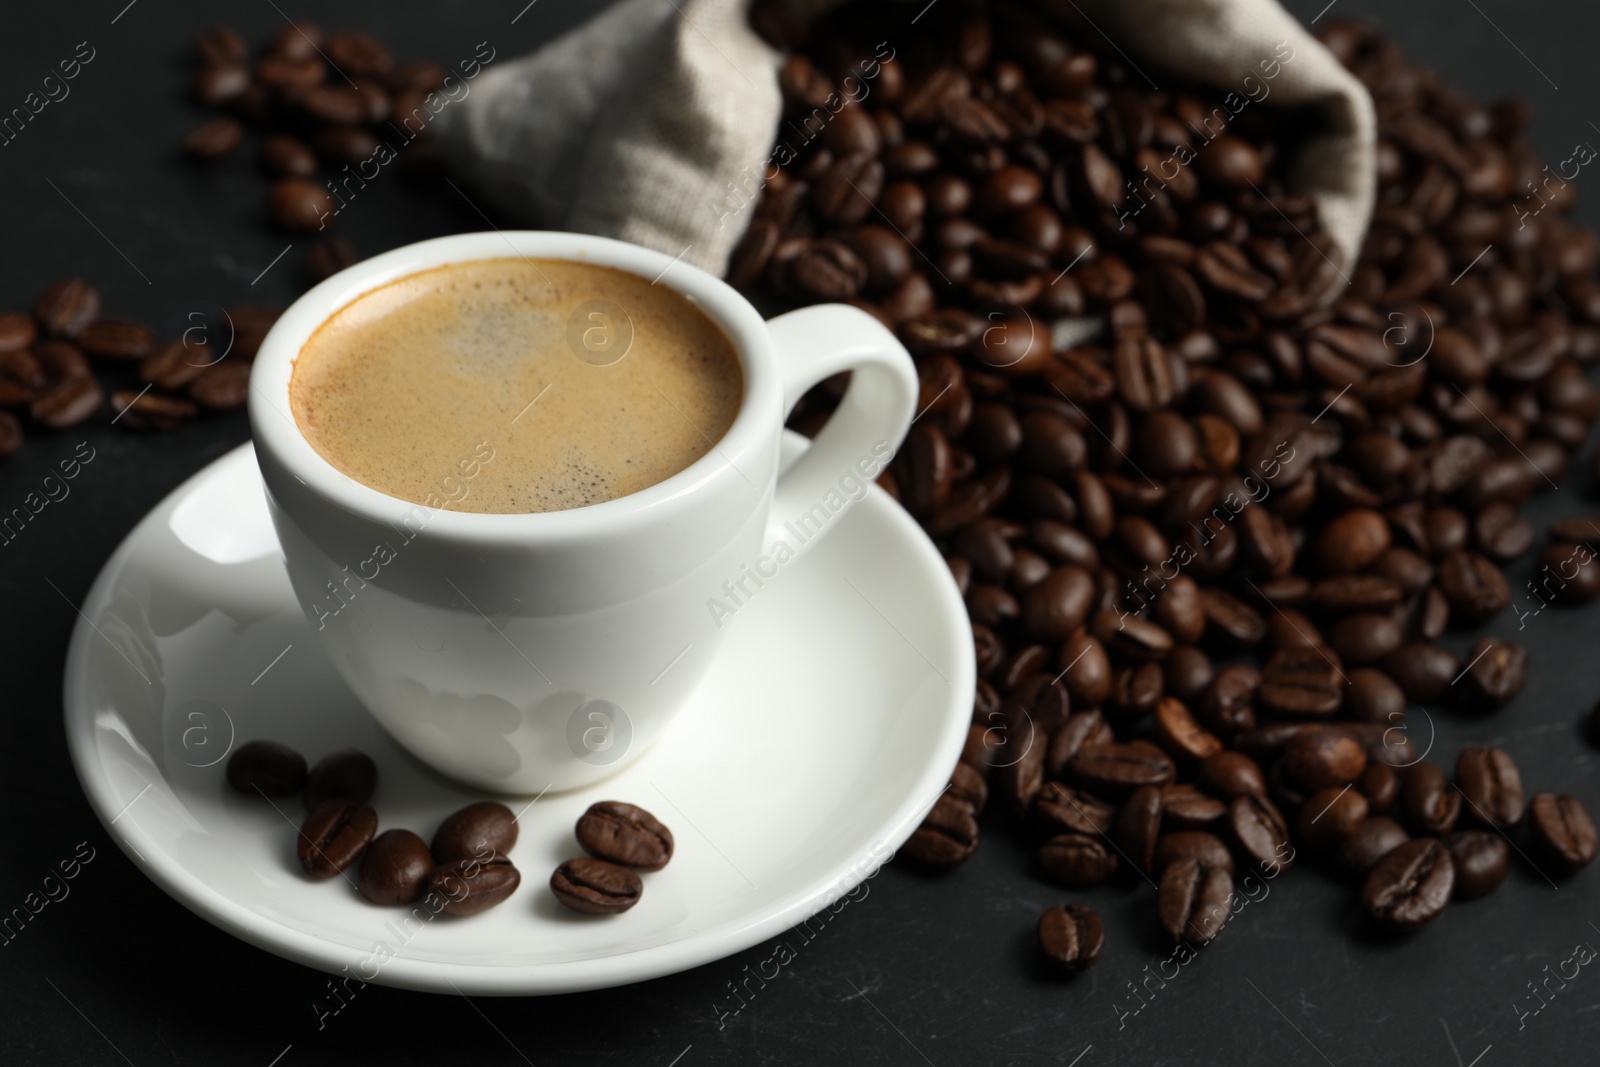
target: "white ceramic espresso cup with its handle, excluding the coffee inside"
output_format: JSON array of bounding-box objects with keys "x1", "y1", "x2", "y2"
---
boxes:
[{"x1": 250, "y1": 232, "x2": 917, "y2": 793}]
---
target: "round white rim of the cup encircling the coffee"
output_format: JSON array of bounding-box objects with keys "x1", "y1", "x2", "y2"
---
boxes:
[{"x1": 248, "y1": 230, "x2": 782, "y2": 542}]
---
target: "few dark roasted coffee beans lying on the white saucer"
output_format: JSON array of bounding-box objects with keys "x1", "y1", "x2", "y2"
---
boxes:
[{"x1": 226, "y1": 741, "x2": 674, "y2": 915}]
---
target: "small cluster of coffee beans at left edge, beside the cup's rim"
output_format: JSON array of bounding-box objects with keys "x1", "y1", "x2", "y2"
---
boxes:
[{"x1": 0, "y1": 278, "x2": 280, "y2": 459}]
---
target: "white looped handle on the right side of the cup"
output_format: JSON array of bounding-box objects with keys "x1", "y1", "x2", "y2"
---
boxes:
[{"x1": 763, "y1": 304, "x2": 918, "y2": 555}]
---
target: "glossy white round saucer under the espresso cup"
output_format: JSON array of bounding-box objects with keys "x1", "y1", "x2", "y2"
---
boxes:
[{"x1": 66, "y1": 435, "x2": 974, "y2": 995}]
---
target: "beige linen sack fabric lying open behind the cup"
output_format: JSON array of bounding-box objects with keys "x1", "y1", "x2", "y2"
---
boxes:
[{"x1": 438, "y1": 0, "x2": 1376, "y2": 287}]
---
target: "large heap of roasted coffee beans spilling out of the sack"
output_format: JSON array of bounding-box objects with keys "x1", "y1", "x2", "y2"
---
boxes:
[{"x1": 728, "y1": 5, "x2": 1600, "y2": 971}]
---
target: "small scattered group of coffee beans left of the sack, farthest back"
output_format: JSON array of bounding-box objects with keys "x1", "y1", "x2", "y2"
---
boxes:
[{"x1": 182, "y1": 22, "x2": 446, "y2": 280}]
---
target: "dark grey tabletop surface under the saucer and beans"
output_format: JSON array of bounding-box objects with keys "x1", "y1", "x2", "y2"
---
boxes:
[{"x1": 0, "y1": 0, "x2": 1600, "y2": 1067}]
